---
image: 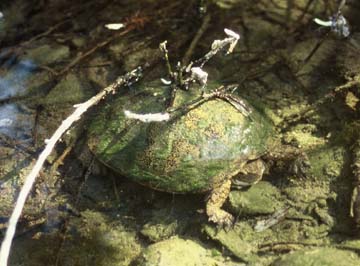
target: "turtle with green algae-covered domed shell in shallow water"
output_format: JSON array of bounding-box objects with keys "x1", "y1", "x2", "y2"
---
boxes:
[{"x1": 88, "y1": 82, "x2": 273, "y2": 227}]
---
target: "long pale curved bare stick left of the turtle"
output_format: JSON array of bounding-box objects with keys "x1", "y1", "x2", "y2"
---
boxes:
[{"x1": 0, "y1": 69, "x2": 138, "y2": 266}]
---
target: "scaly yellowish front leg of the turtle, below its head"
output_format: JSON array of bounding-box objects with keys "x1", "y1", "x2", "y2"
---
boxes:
[{"x1": 206, "y1": 179, "x2": 234, "y2": 228}]
